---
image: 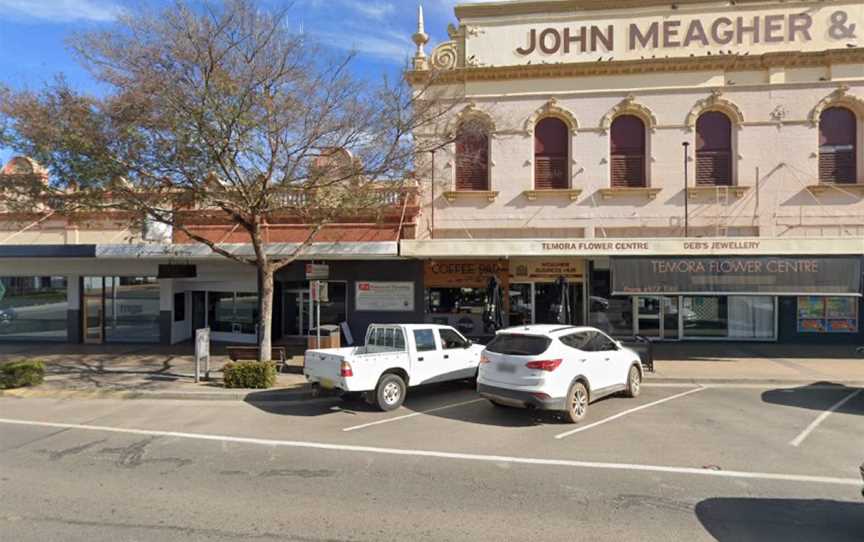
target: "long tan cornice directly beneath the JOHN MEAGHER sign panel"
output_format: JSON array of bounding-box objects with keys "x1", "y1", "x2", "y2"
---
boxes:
[{"x1": 408, "y1": 47, "x2": 864, "y2": 84}]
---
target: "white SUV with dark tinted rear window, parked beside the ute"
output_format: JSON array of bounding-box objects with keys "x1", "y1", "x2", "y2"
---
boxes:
[{"x1": 477, "y1": 325, "x2": 642, "y2": 423}]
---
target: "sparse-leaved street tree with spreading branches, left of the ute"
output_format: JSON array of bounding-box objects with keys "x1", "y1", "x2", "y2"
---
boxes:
[{"x1": 0, "y1": 0, "x2": 459, "y2": 366}]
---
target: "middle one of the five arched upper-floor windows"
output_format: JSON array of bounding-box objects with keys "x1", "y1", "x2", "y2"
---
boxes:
[{"x1": 610, "y1": 115, "x2": 647, "y2": 188}]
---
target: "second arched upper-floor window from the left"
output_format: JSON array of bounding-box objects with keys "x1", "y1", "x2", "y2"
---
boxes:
[{"x1": 534, "y1": 117, "x2": 570, "y2": 190}]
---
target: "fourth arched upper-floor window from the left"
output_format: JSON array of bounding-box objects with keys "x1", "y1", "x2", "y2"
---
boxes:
[{"x1": 696, "y1": 111, "x2": 732, "y2": 186}]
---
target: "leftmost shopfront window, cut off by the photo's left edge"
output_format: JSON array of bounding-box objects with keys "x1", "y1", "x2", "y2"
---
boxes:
[{"x1": 0, "y1": 277, "x2": 69, "y2": 341}]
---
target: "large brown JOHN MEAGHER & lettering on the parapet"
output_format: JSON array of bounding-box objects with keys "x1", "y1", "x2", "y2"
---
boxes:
[{"x1": 516, "y1": 10, "x2": 859, "y2": 56}]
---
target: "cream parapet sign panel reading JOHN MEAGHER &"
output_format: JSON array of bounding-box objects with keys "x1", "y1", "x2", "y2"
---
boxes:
[{"x1": 469, "y1": 2, "x2": 864, "y2": 65}]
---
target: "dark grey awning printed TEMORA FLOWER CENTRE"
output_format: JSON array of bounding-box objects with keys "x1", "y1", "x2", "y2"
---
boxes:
[{"x1": 611, "y1": 256, "x2": 861, "y2": 296}]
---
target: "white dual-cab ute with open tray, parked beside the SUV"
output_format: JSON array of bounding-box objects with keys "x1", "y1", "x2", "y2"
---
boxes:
[{"x1": 303, "y1": 324, "x2": 483, "y2": 411}]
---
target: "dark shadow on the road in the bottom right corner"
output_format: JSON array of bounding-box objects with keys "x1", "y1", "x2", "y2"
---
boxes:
[{"x1": 696, "y1": 498, "x2": 864, "y2": 542}]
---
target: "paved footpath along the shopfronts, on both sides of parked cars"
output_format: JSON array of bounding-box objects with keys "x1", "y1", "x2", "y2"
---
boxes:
[{"x1": 0, "y1": 343, "x2": 864, "y2": 401}]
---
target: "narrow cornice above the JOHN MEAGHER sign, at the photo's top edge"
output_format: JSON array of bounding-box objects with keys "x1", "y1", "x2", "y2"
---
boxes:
[{"x1": 455, "y1": 0, "x2": 816, "y2": 20}]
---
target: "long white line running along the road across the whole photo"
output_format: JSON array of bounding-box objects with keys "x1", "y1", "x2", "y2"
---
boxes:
[{"x1": 0, "y1": 418, "x2": 861, "y2": 487}]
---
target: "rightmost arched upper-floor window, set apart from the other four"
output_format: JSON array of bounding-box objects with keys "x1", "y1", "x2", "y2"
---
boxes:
[{"x1": 819, "y1": 107, "x2": 858, "y2": 183}]
